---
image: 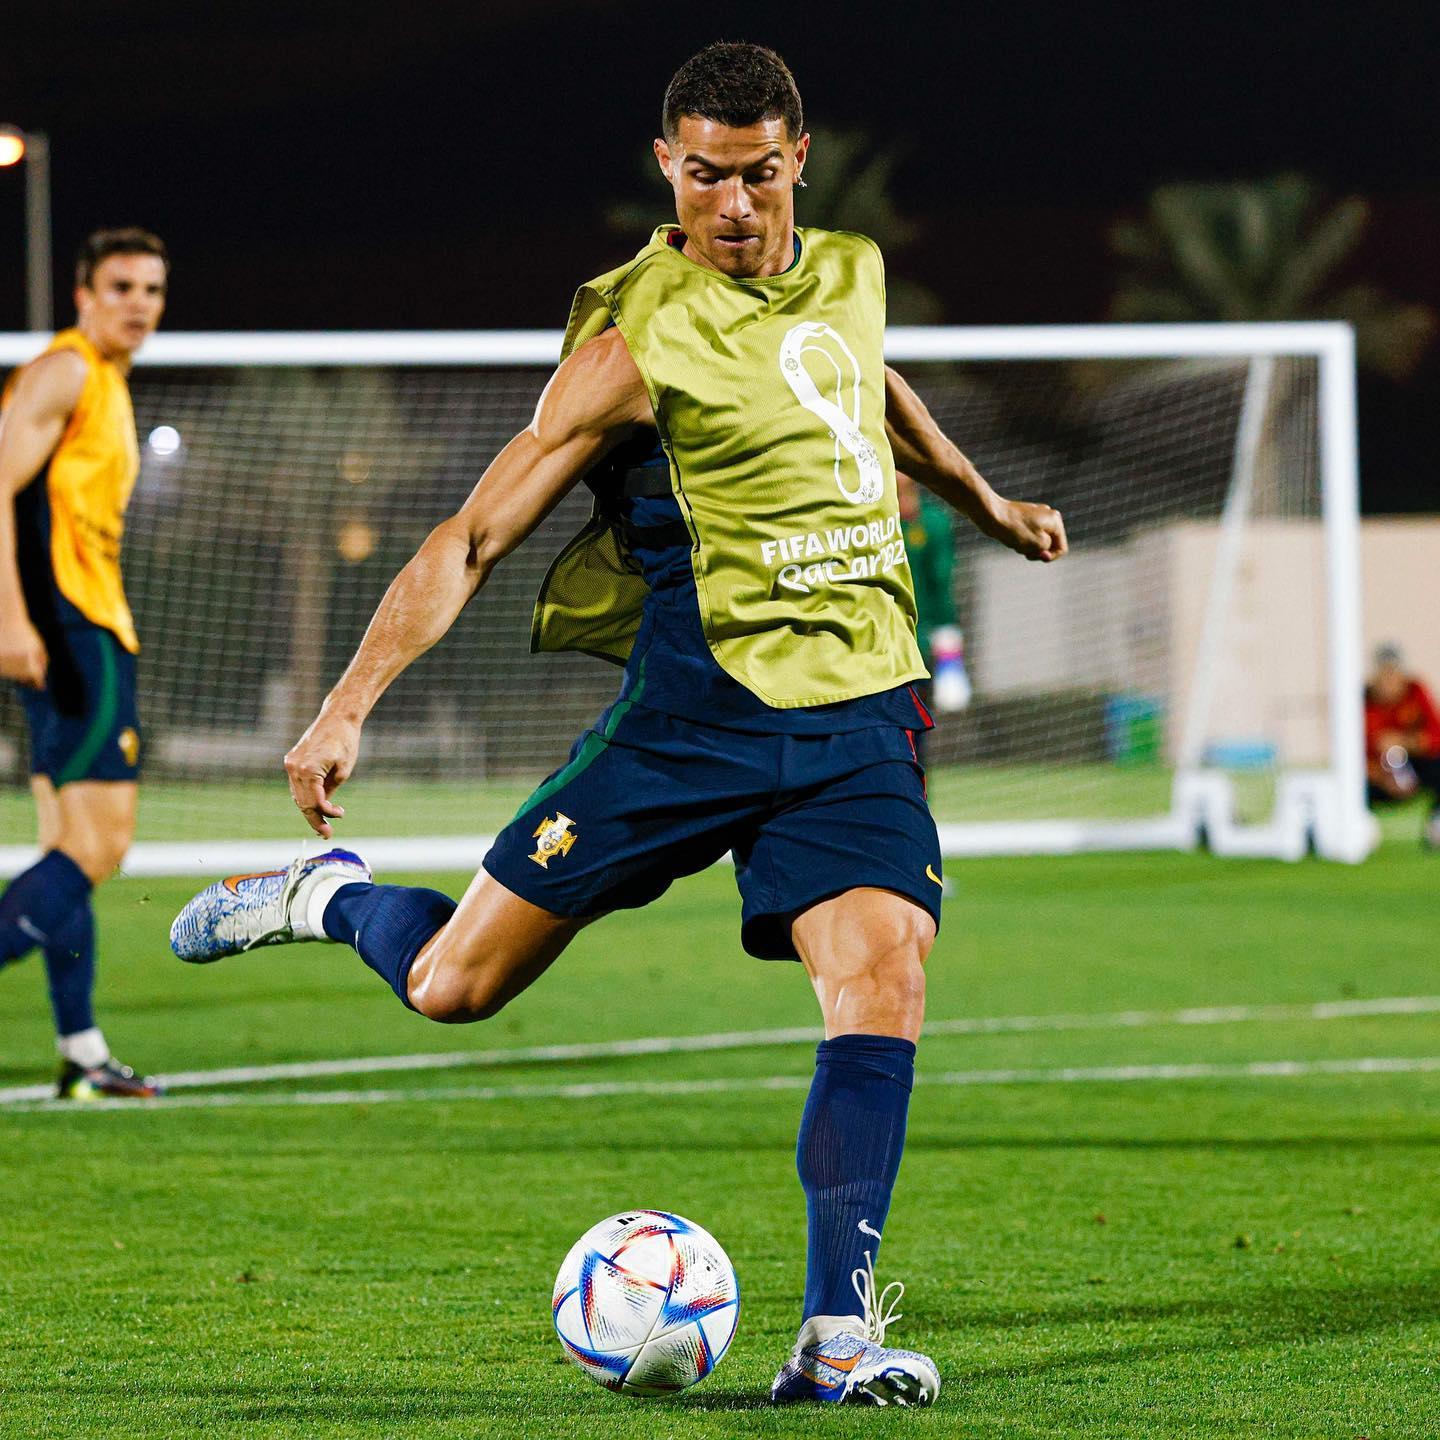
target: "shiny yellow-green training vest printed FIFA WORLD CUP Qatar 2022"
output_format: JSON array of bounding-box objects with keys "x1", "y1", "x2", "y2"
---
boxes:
[{"x1": 531, "y1": 226, "x2": 926, "y2": 710}]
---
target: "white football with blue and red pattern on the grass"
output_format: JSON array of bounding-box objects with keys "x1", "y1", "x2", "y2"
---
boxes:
[{"x1": 550, "y1": 1210, "x2": 740, "y2": 1395}]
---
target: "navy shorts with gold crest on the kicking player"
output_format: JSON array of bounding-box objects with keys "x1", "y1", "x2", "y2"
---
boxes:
[{"x1": 485, "y1": 700, "x2": 940, "y2": 960}]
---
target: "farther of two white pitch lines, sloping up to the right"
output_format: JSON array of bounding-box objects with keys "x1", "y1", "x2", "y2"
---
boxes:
[{"x1": 0, "y1": 995, "x2": 1440, "y2": 1104}]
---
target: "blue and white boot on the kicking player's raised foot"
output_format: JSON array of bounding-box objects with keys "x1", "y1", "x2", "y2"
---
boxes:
[{"x1": 170, "y1": 850, "x2": 370, "y2": 965}]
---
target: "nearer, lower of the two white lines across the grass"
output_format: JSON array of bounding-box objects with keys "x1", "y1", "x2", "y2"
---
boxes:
[{"x1": 8, "y1": 1056, "x2": 1440, "y2": 1115}]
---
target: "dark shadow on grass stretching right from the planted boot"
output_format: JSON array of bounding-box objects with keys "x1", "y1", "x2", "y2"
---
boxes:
[{"x1": 944, "y1": 1273, "x2": 1440, "y2": 1381}]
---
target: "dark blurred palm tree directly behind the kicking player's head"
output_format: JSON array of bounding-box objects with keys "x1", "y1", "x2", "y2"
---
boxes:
[{"x1": 605, "y1": 127, "x2": 942, "y2": 325}]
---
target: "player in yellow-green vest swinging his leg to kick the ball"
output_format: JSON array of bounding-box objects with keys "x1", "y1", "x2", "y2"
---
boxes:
[{"x1": 171, "y1": 43, "x2": 1066, "y2": 1404}]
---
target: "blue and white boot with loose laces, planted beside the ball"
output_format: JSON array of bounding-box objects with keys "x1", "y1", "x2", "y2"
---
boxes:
[{"x1": 770, "y1": 1250, "x2": 940, "y2": 1405}]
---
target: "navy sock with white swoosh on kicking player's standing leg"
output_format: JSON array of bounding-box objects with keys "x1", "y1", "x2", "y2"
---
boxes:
[{"x1": 795, "y1": 1035, "x2": 914, "y2": 1319}]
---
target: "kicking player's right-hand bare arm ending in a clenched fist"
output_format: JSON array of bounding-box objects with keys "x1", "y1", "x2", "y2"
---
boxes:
[{"x1": 886, "y1": 366, "x2": 1068, "y2": 560}]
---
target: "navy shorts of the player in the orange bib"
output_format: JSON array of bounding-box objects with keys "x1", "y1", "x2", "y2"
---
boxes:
[{"x1": 16, "y1": 625, "x2": 140, "y2": 789}]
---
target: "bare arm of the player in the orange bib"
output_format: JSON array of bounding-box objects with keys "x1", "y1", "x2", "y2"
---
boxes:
[{"x1": 0, "y1": 351, "x2": 85, "y2": 688}]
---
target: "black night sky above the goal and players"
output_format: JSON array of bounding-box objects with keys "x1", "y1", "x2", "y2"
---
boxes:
[{"x1": 0, "y1": 0, "x2": 1440, "y2": 511}]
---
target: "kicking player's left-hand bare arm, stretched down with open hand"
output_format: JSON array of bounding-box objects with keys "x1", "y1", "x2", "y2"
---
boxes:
[{"x1": 285, "y1": 330, "x2": 654, "y2": 838}]
